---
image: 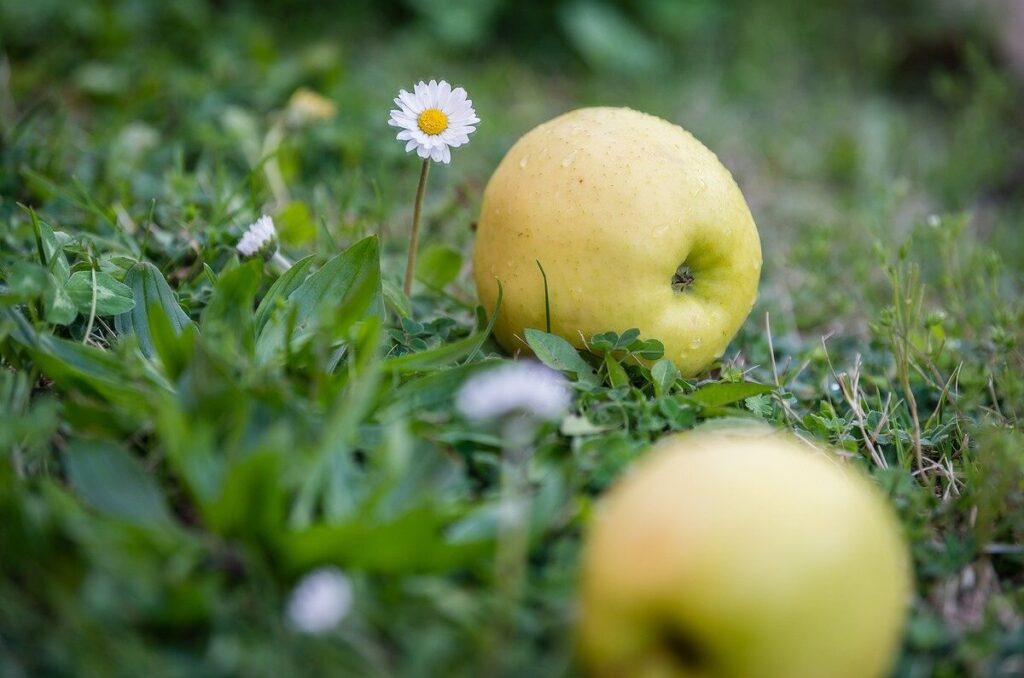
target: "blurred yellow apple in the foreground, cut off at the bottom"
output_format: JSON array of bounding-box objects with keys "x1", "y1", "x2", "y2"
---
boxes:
[{"x1": 578, "y1": 426, "x2": 911, "y2": 678}]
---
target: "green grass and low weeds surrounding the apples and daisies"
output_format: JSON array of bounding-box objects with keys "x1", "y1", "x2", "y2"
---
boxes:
[{"x1": 0, "y1": 0, "x2": 1024, "y2": 676}]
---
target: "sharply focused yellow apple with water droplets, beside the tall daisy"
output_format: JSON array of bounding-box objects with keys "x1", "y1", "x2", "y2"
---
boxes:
[{"x1": 474, "y1": 108, "x2": 761, "y2": 376}]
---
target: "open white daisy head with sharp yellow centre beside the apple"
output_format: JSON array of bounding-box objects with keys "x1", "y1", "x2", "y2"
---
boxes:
[{"x1": 388, "y1": 80, "x2": 480, "y2": 165}]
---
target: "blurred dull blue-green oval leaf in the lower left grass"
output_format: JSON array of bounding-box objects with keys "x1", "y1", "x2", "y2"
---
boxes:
[{"x1": 63, "y1": 441, "x2": 171, "y2": 527}]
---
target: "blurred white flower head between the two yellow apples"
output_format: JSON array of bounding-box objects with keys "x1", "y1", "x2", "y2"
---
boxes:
[{"x1": 456, "y1": 361, "x2": 572, "y2": 420}]
